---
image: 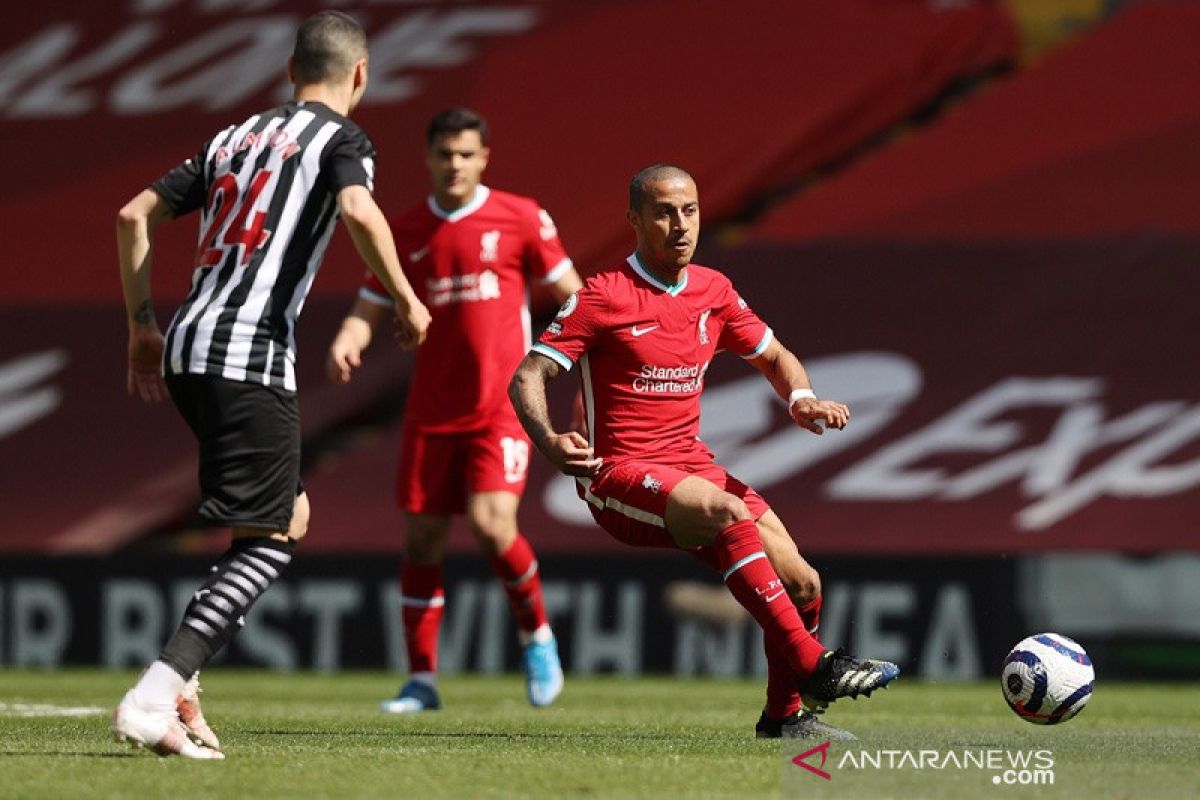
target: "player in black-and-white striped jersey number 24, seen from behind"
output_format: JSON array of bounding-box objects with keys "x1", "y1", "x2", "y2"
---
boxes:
[{"x1": 113, "y1": 11, "x2": 430, "y2": 758}]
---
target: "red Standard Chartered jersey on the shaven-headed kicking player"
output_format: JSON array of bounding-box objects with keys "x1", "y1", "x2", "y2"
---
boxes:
[{"x1": 533, "y1": 254, "x2": 773, "y2": 464}]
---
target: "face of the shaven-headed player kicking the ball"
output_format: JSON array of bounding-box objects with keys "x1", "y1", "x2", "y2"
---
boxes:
[{"x1": 629, "y1": 176, "x2": 700, "y2": 271}]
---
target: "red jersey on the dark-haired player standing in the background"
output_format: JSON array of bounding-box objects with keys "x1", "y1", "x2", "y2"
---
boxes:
[{"x1": 360, "y1": 186, "x2": 571, "y2": 433}]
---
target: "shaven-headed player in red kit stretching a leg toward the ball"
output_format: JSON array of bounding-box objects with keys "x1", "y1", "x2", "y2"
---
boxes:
[{"x1": 509, "y1": 164, "x2": 899, "y2": 739}]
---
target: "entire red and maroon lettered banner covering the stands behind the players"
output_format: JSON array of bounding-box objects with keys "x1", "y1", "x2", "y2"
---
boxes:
[{"x1": 0, "y1": 0, "x2": 1200, "y2": 554}]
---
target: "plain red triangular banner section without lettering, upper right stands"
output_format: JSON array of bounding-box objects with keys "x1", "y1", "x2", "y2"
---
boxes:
[{"x1": 752, "y1": 2, "x2": 1200, "y2": 241}]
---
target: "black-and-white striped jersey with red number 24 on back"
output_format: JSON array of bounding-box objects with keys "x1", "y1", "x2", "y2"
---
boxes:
[{"x1": 152, "y1": 101, "x2": 376, "y2": 391}]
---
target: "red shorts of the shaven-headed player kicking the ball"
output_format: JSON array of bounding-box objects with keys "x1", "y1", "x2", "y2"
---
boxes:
[{"x1": 576, "y1": 461, "x2": 770, "y2": 548}]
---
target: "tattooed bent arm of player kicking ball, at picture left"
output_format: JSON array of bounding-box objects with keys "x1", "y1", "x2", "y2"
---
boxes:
[{"x1": 509, "y1": 353, "x2": 601, "y2": 477}]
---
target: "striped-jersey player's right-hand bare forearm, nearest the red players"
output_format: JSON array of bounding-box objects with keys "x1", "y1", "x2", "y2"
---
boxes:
[{"x1": 337, "y1": 185, "x2": 432, "y2": 348}]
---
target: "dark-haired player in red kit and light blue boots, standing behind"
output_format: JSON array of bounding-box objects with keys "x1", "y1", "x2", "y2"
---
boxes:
[{"x1": 328, "y1": 108, "x2": 582, "y2": 714}]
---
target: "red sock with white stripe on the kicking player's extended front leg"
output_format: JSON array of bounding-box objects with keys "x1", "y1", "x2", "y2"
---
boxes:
[{"x1": 713, "y1": 519, "x2": 824, "y2": 678}]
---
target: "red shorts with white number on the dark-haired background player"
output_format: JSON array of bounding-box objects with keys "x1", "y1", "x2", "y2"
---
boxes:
[{"x1": 396, "y1": 420, "x2": 529, "y2": 515}]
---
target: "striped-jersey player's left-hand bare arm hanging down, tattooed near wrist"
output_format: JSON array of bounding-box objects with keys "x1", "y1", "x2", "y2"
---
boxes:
[{"x1": 116, "y1": 190, "x2": 172, "y2": 403}]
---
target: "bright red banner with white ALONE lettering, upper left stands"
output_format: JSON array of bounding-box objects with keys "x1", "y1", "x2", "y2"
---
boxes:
[{"x1": 0, "y1": 0, "x2": 1015, "y2": 302}]
